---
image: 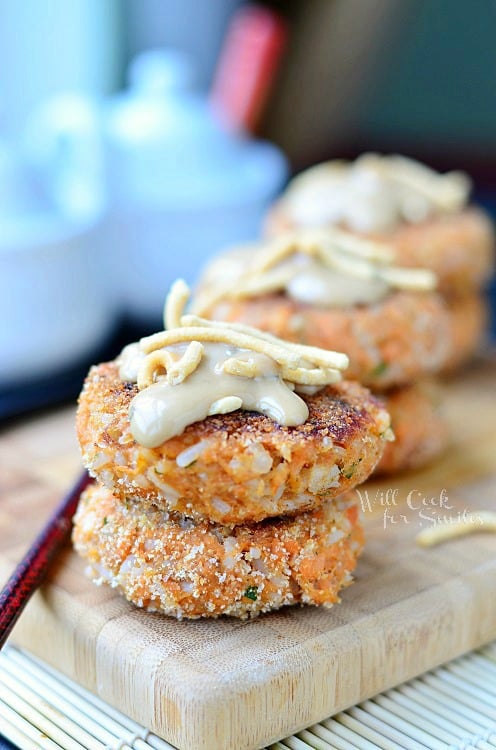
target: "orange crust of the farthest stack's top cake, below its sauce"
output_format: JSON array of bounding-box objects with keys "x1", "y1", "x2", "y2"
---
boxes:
[{"x1": 265, "y1": 200, "x2": 495, "y2": 294}]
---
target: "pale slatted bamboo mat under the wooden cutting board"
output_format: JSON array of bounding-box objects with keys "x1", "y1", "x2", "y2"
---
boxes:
[{"x1": 0, "y1": 642, "x2": 496, "y2": 750}]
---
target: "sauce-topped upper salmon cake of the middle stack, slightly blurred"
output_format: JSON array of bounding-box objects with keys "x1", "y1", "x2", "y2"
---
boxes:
[{"x1": 193, "y1": 230, "x2": 455, "y2": 391}]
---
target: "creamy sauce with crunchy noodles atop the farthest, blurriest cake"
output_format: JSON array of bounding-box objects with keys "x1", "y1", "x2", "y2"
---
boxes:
[{"x1": 283, "y1": 154, "x2": 470, "y2": 232}]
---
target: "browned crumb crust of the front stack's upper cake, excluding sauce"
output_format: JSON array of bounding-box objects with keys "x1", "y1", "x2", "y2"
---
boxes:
[{"x1": 77, "y1": 363, "x2": 389, "y2": 524}]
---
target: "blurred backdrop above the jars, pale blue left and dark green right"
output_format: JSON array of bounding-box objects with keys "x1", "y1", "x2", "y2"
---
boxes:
[{"x1": 0, "y1": 0, "x2": 496, "y2": 168}]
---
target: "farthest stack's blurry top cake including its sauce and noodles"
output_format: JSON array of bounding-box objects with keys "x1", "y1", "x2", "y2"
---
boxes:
[{"x1": 266, "y1": 154, "x2": 495, "y2": 294}]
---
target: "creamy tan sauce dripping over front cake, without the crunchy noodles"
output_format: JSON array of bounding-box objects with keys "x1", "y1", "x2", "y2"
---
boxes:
[{"x1": 118, "y1": 343, "x2": 308, "y2": 448}]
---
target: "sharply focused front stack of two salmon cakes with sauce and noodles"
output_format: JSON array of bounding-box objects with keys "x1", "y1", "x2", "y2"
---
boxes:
[{"x1": 73, "y1": 282, "x2": 392, "y2": 618}]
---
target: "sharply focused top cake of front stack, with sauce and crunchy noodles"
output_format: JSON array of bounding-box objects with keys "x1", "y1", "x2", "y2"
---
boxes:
[{"x1": 77, "y1": 282, "x2": 392, "y2": 525}]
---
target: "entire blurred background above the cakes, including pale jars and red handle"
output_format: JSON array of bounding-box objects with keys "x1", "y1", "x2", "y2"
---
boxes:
[{"x1": 0, "y1": 0, "x2": 496, "y2": 418}]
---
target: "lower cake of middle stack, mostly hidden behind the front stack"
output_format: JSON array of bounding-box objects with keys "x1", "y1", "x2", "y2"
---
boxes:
[{"x1": 374, "y1": 382, "x2": 449, "y2": 474}]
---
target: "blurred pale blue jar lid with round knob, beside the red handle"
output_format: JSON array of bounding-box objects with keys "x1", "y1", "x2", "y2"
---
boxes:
[{"x1": 104, "y1": 50, "x2": 287, "y2": 209}]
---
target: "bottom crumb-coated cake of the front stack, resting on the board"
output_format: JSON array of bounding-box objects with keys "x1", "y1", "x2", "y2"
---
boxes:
[{"x1": 73, "y1": 486, "x2": 363, "y2": 619}]
